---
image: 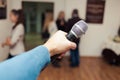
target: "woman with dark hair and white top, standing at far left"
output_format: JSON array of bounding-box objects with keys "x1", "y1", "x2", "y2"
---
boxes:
[{"x1": 3, "y1": 10, "x2": 25, "y2": 58}]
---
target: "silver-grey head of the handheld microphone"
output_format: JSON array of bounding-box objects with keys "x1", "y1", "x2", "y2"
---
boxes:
[{"x1": 71, "y1": 20, "x2": 88, "y2": 37}]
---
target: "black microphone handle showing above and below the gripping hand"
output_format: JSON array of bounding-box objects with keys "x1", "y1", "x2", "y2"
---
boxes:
[{"x1": 51, "y1": 32, "x2": 77, "y2": 64}]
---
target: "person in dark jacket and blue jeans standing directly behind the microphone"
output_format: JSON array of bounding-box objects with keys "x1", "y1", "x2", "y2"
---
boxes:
[{"x1": 66, "y1": 9, "x2": 81, "y2": 67}]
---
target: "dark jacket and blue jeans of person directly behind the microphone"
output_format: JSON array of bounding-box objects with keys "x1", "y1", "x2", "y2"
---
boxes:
[{"x1": 66, "y1": 17, "x2": 81, "y2": 66}]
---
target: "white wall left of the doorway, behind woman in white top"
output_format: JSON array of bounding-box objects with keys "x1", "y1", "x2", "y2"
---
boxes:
[{"x1": 0, "y1": 0, "x2": 21, "y2": 61}]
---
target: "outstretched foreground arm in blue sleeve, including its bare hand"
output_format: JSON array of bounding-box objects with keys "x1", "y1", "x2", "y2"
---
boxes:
[{"x1": 0, "y1": 31, "x2": 76, "y2": 80}]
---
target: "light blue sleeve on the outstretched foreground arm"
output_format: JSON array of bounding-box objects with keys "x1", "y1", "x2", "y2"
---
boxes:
[{"x1": 0, "y1": 46, "x2": 50, "y2": 80}]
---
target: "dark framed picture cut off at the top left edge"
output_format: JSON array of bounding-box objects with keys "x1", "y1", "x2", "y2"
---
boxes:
[{"x1": 0, "y1": 0, "x2": 7, "y2": 19}]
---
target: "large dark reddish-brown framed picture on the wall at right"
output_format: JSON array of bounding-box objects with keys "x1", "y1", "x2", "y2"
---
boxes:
[{"x1": 86, "y1": 0, "x2": 105, "y2": 24}]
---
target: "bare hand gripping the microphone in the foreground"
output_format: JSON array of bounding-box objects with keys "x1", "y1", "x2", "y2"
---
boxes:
[{"x1": 44, "y1": 31, "x2": 76, "y2": 56}]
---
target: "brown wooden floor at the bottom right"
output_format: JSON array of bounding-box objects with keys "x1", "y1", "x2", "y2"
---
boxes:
[{"x1": 38, "y1": 57, "x2": 120, "y2": 80}]
